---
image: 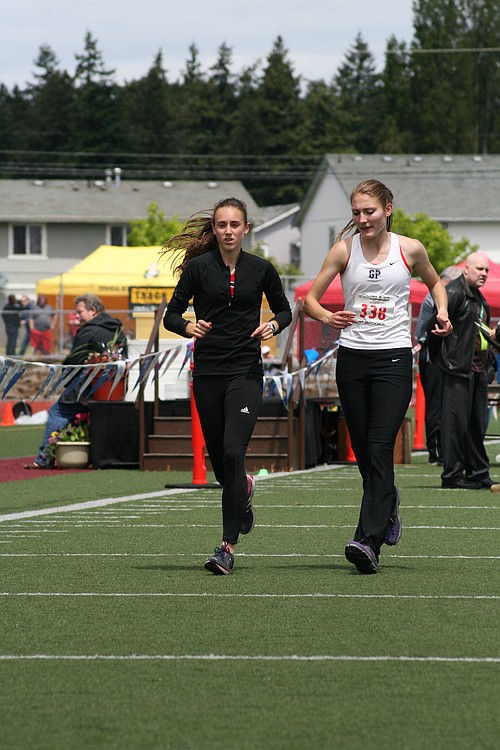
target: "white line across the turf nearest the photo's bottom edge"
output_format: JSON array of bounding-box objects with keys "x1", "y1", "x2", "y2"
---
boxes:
[{"x1": 0, "y1": 654, "x2": 500, "y2": 664}]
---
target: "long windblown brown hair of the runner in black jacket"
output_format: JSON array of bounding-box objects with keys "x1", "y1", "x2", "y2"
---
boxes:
[{"x1": 160, "y1": 198, "x2": 248, "y2": 276}]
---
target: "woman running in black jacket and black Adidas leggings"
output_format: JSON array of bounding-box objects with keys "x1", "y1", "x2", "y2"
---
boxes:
[{"x1": 163, "y1": 198, "x2": 292, "y2": 575}]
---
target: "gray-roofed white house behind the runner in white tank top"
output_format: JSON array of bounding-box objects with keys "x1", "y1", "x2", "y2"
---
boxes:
[{"x1": 295, "y1": 154, "x2": 500, "y2": 278}]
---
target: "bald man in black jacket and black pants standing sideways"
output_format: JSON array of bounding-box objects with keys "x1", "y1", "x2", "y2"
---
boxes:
[{"x1": 430, "y1": 253, "x2": 495, "y2": 490}]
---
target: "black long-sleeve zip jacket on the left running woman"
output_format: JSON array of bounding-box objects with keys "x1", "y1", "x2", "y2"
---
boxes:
[{"x1": 163, "y1": 249, "x2": 292, "y2": 376}]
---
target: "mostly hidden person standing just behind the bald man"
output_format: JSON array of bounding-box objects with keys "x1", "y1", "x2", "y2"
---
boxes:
[{"x1": 415, "y1": 266, "x2": 462, "y2": 466}]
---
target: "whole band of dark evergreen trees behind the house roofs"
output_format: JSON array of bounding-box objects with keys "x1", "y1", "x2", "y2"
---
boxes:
[{"x1": 0, "y1": 9, "x2": 500, "y2": 189}]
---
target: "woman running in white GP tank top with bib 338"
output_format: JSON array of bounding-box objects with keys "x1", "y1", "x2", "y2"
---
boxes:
[{"x1": 304, "y1": 180, "x2": 452, "y2": 573}]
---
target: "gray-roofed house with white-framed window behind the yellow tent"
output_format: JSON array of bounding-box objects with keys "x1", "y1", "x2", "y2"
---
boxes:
[{"x1": 0, "y1": 178, "x2": 262, "y2": 306}]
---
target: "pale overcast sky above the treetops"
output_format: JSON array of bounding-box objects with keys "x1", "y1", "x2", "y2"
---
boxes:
[{"x1": 0, "y1": 0, "x2": 413, "y2": 88}]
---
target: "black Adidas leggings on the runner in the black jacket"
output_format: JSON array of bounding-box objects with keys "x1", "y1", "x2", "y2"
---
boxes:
[{"x1": 193, "y1": 373, "x2": 263, "y2": 544}]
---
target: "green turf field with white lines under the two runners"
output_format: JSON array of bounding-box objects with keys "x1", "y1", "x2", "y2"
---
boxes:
[{"x1": 0, "y1": 428, "x2": 500, "y2": 750}]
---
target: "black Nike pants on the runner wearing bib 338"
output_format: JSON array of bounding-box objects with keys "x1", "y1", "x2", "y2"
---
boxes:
[{"x1": 336, "y1": 346, "x2": 412, "y2": 555}]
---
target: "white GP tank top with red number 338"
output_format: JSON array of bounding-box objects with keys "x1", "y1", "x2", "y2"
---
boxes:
[{"x1": 339, "y1": 232, "x2": 411, "y2": 349}]
